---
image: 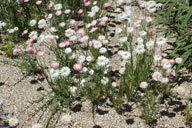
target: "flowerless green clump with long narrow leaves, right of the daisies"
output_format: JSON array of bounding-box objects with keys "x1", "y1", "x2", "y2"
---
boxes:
[{"x1": 152, "y1": 0, "x2": 192, "y2": 72}]
